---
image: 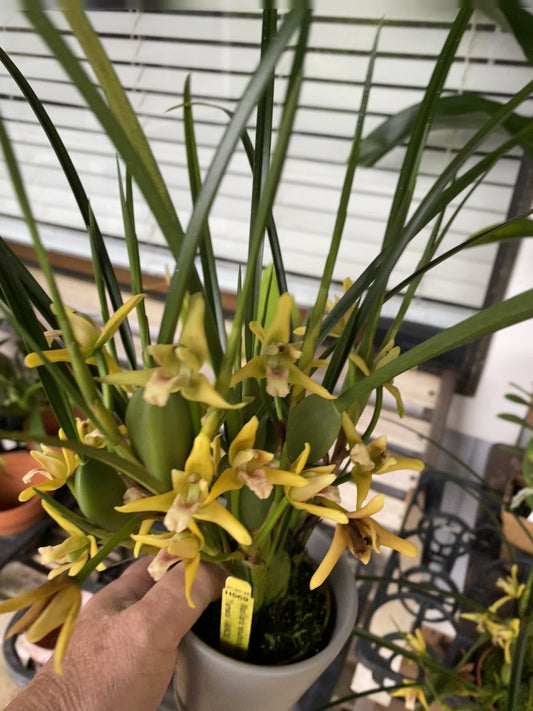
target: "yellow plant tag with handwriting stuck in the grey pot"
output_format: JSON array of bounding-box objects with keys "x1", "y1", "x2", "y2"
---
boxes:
[{"x1": 220, "y1": 576, "x2": 254, "y2": 656}]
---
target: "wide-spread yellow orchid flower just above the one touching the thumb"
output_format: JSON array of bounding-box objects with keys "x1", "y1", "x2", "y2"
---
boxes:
[{"x1": 116, "y1": 432, "x2": 252, "y2": 546}]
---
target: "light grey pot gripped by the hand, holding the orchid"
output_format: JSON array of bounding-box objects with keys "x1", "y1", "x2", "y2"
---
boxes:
[{"x1": 174, "y1": 531, "x2": 357, "y2": 711}]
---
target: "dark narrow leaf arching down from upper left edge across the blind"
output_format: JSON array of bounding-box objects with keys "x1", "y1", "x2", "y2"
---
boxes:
[{"x1": 0, "y1": 48, "x2": 135, "y2": 363}]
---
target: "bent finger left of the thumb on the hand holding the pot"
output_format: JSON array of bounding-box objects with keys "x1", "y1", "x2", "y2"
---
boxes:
[{"x1": 82, "y1": 556, "x2": 154, "y2": 613}]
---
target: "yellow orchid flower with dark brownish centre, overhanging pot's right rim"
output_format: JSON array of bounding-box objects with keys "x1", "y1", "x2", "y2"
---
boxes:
[{"x1": 310, "y1": 494, "x2": 418, "y2": 590}]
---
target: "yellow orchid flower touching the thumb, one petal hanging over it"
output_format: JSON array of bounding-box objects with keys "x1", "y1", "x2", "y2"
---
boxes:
[{"x1": 131, "y1": 521, "x2": 205, "y2": 607}]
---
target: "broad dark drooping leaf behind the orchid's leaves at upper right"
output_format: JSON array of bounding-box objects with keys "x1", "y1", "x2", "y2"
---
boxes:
[{"x1": 359, "y1": 92, "x2": 533, "y2": 167}]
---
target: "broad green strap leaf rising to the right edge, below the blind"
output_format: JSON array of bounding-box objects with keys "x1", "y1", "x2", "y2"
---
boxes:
[{"x1": 335, "y1": 289, "x2": 533, "y2": 411}]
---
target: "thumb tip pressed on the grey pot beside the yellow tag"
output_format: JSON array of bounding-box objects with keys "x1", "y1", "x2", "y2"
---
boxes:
[{"x1": 135, "y1": 563, "x2": 226, "y2": 645}]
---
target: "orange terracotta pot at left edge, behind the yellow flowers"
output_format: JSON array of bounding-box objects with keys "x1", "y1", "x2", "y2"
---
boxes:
[{"x1": 0, "y1": 450, "x2": 46, "y2": 536}]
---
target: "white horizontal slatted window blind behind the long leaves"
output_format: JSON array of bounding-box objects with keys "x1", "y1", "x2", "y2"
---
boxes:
[{"x1": 0, "y1": 0, "x2": 533, "y2": 326}]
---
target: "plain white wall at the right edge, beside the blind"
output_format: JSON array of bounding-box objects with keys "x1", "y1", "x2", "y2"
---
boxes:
[{"x1": 448, "y1": 239, "x2": 533, "y2": 444}]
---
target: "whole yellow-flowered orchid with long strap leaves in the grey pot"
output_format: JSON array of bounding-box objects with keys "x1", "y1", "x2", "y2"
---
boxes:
[{"x1": 0, "y1": 0, "x2": 533, "y2": 665}]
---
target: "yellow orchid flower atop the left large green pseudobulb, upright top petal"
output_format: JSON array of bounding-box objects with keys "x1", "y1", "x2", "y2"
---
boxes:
[{"x1": 100, "y1": 292, "x2": 246, "y2": 410}]
